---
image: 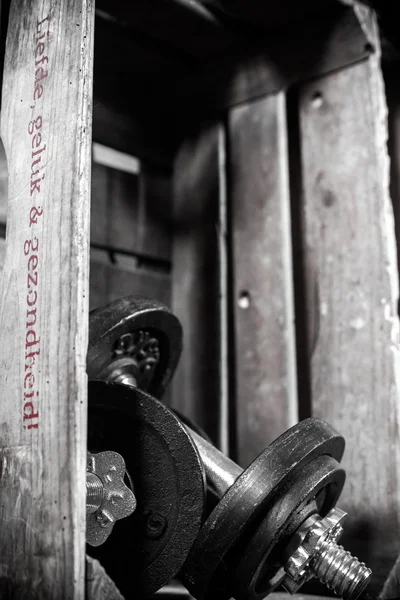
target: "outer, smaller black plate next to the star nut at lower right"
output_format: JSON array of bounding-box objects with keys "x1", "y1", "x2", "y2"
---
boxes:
[{"x1": 233, "y1": 455, "x2": 346, "y2": 600}]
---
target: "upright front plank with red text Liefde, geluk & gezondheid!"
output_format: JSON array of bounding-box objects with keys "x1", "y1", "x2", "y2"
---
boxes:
[{"x1": 0, "y1": 0, "x2": 94, "y2": 600}]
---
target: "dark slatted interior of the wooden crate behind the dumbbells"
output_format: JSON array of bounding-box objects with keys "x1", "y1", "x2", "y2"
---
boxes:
[{"x1": 0, "y1": 0, "x2": 400, "y2": 592}]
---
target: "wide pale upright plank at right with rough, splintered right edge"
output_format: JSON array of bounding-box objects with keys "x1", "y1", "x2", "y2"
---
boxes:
[{"x1": 300, "y1": 22, "x2": 400, "y2": 595}]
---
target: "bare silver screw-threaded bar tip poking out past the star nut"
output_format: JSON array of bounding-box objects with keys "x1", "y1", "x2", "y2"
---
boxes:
[{"x1": 310, "y1": 540, "x2": 372, "y2": 600}]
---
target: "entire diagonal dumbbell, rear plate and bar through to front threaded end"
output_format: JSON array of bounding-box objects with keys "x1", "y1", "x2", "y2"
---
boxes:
[{"x1": 88, "y1": 299, "x2": 370, "y2": 599}]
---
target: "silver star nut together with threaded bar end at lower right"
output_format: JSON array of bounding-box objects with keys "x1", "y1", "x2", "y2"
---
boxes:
[{"x1": 283, "y1": 508, "x2": 372, "y2": 600}]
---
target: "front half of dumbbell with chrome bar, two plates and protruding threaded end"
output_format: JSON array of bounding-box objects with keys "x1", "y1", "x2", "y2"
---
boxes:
[{"x1": 181, "y1": 419, "x2": 372, "y2": 600}]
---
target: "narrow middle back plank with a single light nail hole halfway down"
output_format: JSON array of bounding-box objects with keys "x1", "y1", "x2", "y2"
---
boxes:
[{"x1": 229, "y1": 94, "x2": 297, "y2": 466}]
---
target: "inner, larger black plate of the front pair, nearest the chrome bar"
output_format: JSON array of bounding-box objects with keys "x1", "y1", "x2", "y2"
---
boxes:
[{"x1": 180, "y1": 418, "x2": 344, "y2": 600}]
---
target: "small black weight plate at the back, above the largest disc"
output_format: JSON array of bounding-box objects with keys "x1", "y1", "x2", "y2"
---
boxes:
[{"x1": 87, "y1": 296, "x2": 182, "y2": 398}]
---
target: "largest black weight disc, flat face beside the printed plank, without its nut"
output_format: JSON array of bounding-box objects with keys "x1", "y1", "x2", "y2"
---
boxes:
[{"x1": 87, "y1": 381, "x2": 205, "y2": 600}]
